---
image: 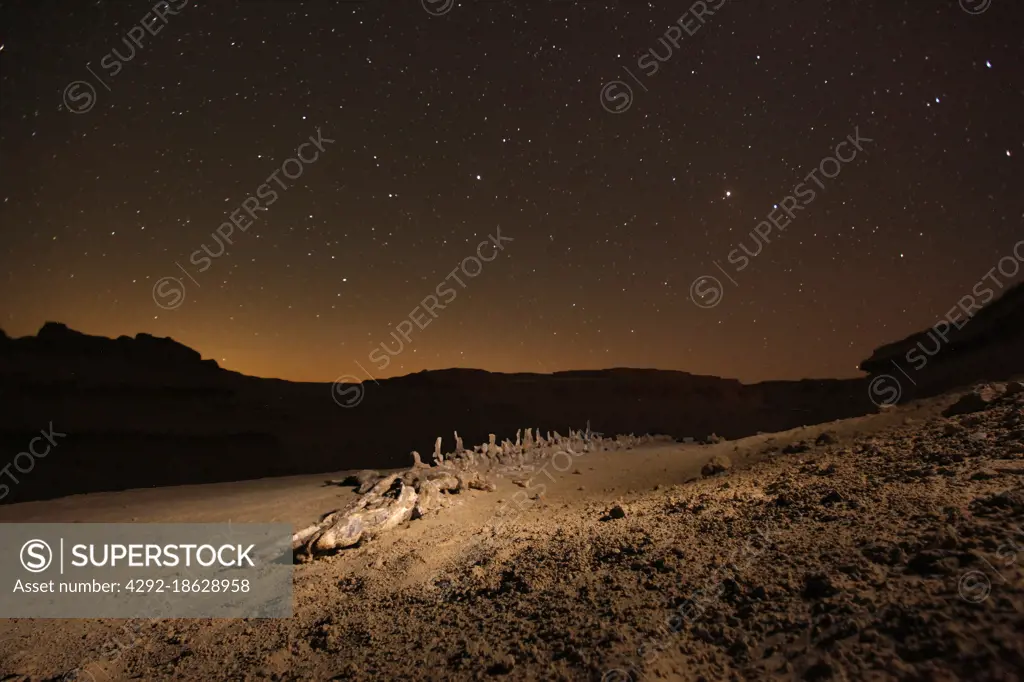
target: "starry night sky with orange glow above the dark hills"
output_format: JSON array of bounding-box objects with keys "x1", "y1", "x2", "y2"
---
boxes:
[{"x1": 0, "y1": 0, "x2": 1024, "y2": 382}]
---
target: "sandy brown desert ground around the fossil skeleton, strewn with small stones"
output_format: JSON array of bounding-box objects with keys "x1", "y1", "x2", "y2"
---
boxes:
[{"x1": 0, "y1": 385, "x2": 1024, "y2": 682}]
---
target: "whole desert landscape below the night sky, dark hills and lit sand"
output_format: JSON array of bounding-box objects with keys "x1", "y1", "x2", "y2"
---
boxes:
[{"x1": 0, "y1": 280, "x2": 1024, "y2": 682}]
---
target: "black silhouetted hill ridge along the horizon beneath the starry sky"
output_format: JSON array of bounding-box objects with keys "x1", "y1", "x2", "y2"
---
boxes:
[{"x1": 0, "y1": 278, "x2": 1024, "y2": 503}]
